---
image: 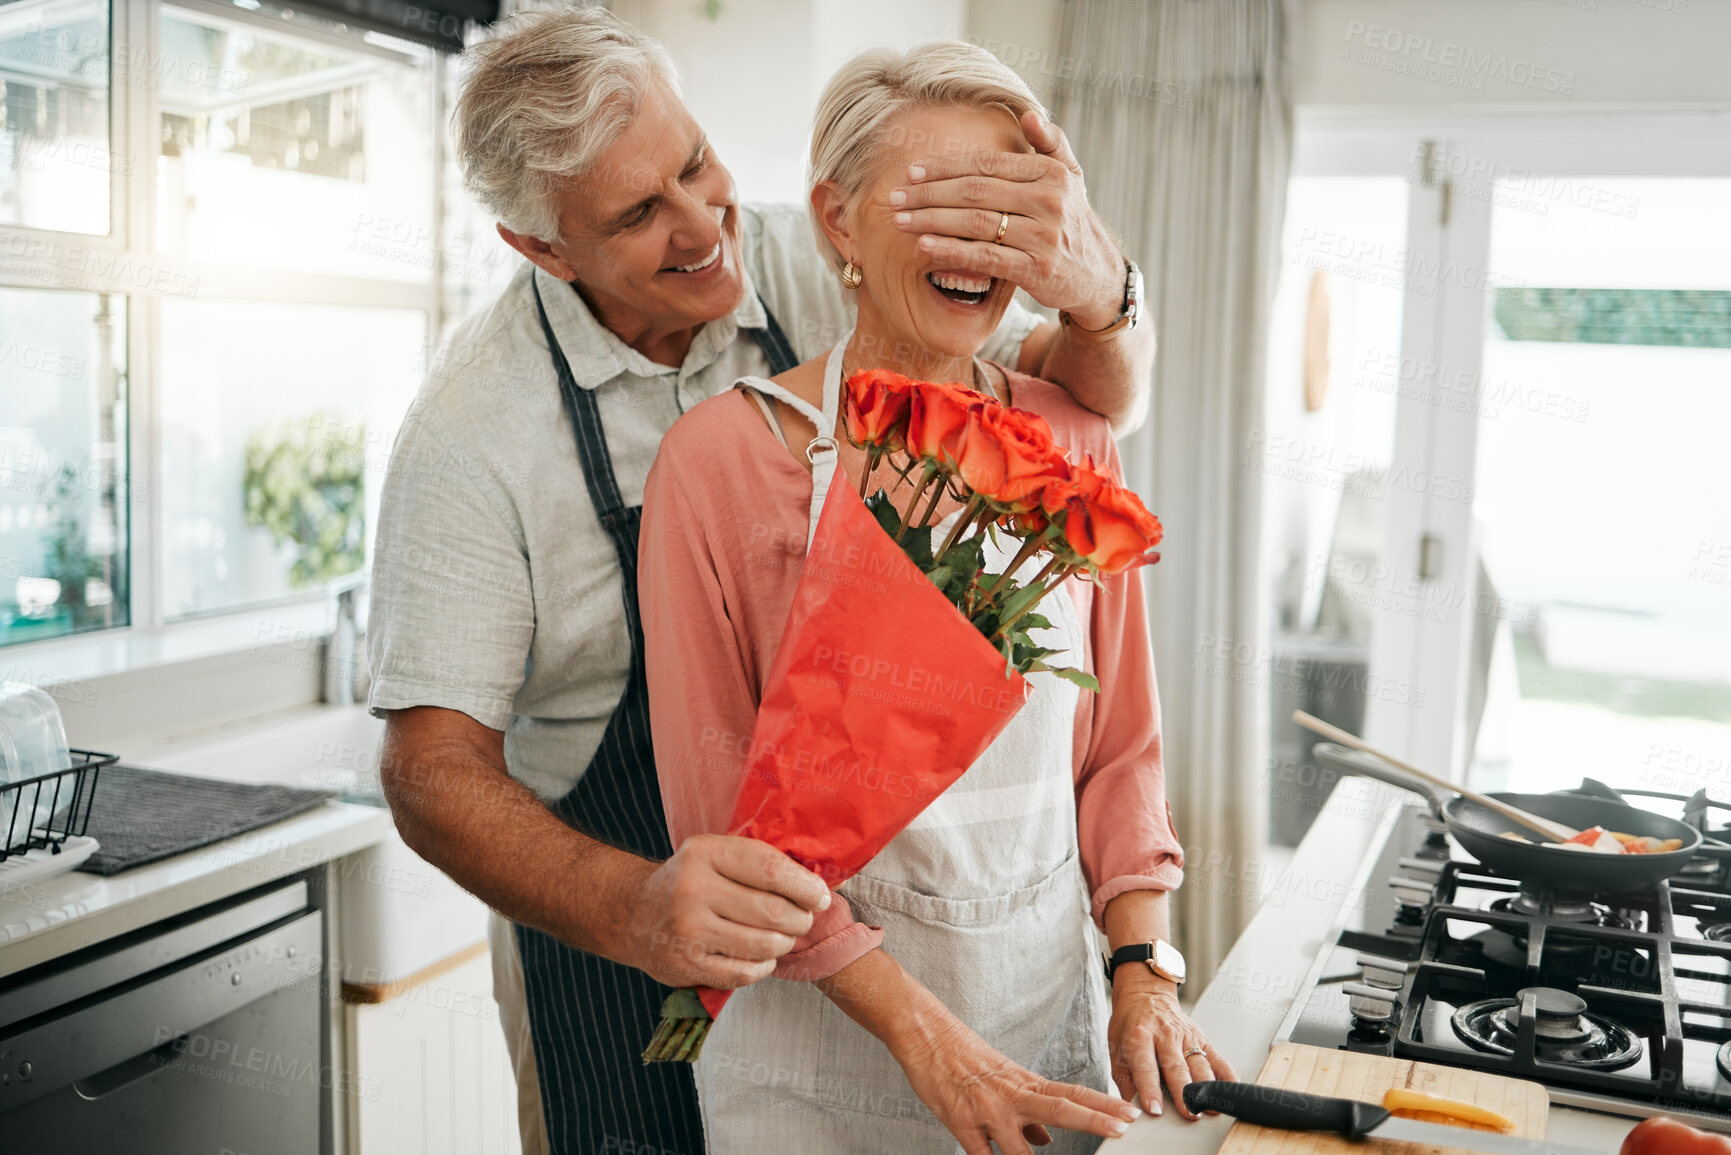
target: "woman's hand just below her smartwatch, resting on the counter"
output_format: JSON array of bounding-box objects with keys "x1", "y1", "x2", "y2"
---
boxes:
[{"x1": 1106, "y1": 966, "x2": 1238, "y2": 1119}]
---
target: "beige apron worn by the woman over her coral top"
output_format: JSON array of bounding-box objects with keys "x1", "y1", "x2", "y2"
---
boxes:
[{"x1": 696, "y1": 338, "x2": 1111, "y2": 1155}]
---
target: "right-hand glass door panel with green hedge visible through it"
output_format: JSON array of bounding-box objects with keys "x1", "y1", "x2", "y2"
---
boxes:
[{"x1": 1466, "y1": 175, "x2": 1731, "y2": 795}]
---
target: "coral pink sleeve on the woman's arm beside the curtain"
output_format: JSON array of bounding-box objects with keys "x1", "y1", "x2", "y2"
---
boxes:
[{"x1": 1075, "y1": 438, "x2": 1184, "y2": 930}]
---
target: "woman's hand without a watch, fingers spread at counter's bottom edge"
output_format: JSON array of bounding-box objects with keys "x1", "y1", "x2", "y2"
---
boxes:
[{"x1": 891, "y1": 1016, "x2": 1141, "y2": 1155}]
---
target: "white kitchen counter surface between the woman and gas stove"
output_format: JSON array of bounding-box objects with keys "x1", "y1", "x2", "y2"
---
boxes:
[{"x1": 1099, "y1": 778, "x2": 1638, "y2": 1155}]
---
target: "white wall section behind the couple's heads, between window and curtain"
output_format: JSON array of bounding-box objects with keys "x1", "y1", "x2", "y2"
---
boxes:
[{"x1": 613, "y1": 0, "x2": 962, "y2": 203}]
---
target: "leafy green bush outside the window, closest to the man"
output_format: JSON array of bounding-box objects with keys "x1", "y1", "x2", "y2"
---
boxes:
[{"x1": 244, "y1": 417, "x2": 367, "y2": 589}]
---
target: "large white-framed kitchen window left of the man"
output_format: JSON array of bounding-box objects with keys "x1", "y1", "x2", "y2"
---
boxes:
[{"x1": 0, "y1": 0, "x2": 477, "y2": 646}]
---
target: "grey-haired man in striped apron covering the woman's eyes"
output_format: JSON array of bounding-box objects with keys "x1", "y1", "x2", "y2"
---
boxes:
[{"x1": 369, "y1": 9, "x2": 1153, "y2": 1155}]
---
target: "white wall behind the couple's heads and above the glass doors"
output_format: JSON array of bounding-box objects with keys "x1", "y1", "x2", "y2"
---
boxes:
[{"x1": 613, "y1": 0, "x2": 1731, "y2": 201}]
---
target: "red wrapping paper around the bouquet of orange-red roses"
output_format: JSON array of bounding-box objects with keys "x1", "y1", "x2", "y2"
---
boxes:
[{"x1": 698, "y1": 473, "x2": 1028, "y2": 1016}]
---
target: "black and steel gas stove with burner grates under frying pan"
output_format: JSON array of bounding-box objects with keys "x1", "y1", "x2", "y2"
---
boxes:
[{"x1": 1279, "y1": 791, "x2": 1731, "y2": 1131}]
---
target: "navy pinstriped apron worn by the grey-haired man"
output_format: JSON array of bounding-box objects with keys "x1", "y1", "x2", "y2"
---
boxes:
[{"x1": 514, "y1": 277, "x2": 796, "y2": 1155}]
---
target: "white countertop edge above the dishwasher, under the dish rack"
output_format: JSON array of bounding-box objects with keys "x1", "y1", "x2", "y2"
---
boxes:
[{"x1": 0, "y1": 802, "x2": 391, "y2": 977}]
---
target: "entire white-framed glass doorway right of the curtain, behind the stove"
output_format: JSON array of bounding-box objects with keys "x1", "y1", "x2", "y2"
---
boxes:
[{"x1": 1267, "y1": 113, "x2": 1731, "y2": 810}]
